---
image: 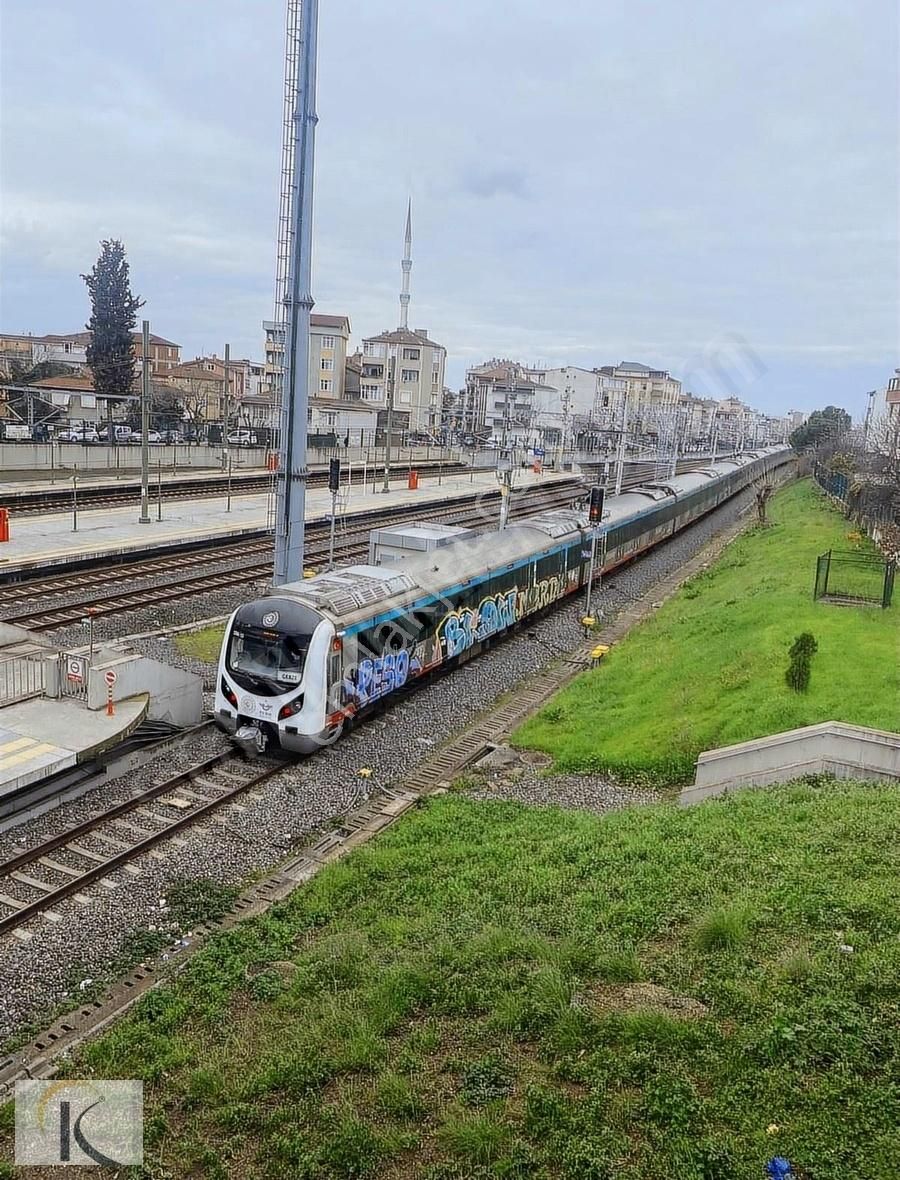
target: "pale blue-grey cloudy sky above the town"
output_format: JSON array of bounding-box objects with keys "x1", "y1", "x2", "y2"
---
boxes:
[{"x1": 0, "y1": 0, "x2": 900, "y2": 413}]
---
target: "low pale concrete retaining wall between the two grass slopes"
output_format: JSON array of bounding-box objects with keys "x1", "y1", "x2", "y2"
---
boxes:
[{"x1": 678, "y1": 721, "x2": 900, "y2": 806}]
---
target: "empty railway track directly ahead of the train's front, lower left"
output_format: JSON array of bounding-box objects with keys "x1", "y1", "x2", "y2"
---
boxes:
[{"x1": 0, "y1": 750, "x2": 284, "y2": 936}]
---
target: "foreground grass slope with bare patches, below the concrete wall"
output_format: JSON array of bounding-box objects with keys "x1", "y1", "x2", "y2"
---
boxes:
[{"x1": 0, "y1": 781, "x2": 900, "y2": 1180}]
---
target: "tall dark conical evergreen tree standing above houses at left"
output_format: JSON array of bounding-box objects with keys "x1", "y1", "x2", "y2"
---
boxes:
[{"x1": 81, "y1": 238, "x2": 144, "y2": 446}]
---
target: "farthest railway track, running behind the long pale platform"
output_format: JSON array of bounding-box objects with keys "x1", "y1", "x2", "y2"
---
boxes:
[{"x1": 2, "y1": 459, "x2": 467, "y2": 516}]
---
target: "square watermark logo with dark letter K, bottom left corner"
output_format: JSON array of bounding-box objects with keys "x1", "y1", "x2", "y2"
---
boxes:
[{"x1": 15, "y1": 1080, "x2": 144, "y2": 1168}]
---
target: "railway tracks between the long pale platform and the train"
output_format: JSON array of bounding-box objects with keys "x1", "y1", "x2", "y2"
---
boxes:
[{"x1": 0, "y1": 480, "x2": 587, "y2": 631}]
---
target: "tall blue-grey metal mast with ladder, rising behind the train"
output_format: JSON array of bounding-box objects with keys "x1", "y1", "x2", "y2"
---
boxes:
[{"x1": 272, "y1": 0, "x2": 318, "y2": 586}]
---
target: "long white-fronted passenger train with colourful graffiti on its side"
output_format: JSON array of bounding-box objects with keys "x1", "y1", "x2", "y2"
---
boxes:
[{"x1": 215, "y1": 447, "x2": 793, "y2": 756}]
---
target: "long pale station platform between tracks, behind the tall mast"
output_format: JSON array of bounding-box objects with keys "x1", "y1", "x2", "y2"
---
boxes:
[{"x1": 0, "y1": 468, "x2": 573, "y2": 579}]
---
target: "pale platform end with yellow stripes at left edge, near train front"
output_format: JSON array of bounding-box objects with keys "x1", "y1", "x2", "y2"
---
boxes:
[{"x1": 0, "y1": 694, "x2": 150, "y2": 805}]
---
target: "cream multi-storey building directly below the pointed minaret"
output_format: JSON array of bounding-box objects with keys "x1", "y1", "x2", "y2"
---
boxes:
[{"x1": 360, "y1": 328, "x2": 447, "y2": 433}]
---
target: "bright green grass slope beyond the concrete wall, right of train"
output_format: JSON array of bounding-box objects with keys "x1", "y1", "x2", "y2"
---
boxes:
[{"x1": 514, "y1": 481, "x2": 900, "y2": 785}]
